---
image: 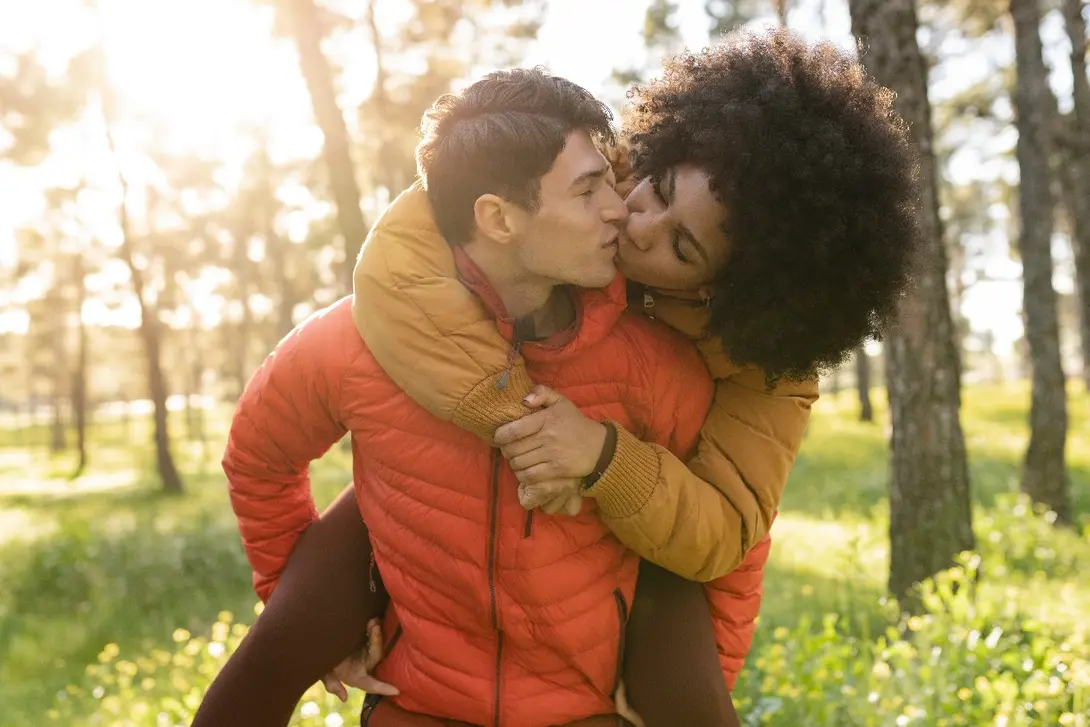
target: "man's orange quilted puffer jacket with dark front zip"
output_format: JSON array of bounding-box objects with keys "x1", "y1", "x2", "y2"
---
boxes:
[{"x1": 223, "y1": 257, "x2": 715, "y2": 727}]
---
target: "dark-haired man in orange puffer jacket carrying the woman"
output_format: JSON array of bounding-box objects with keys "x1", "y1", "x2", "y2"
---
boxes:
[{"x1": 214, "y1": 66, "x2": 732, "y2": 727}]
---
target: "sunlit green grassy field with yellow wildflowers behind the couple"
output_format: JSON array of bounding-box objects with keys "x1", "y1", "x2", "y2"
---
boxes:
[{"x1": 0, "y1": 386, "x2": 1090, "y2": 727}]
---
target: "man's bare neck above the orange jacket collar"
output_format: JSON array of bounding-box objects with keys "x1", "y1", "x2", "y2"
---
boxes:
[{"x1": 463, "y1": 243, "x2": 576, "y2": 338}]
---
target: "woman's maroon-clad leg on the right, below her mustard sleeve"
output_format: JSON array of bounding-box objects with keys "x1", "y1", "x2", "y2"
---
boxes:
[{"x1": 625, "y1": 560, "x2": 739, "y2": 727}]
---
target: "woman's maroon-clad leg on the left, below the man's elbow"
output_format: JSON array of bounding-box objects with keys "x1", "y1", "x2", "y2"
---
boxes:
[{"x1": 193, "y1": 487, "x2": 387, "y2": 727}]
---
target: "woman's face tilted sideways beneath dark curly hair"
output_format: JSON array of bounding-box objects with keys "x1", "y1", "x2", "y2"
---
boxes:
[{"x1": 617, "y1": 165, "x2": 727, "y2": 291}]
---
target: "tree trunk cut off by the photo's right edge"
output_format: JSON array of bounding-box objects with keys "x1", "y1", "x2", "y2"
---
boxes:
[{"x1": 1061, "y1": 0, "x2": 1090, "y2": 391}]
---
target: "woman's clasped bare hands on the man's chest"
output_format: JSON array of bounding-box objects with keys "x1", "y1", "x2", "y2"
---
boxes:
[{"x1": 495, "y1": 386, "x2": 606, "y2": 514}]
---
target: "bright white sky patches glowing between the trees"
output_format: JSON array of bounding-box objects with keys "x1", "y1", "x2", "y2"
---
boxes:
[{"x1": 0, "y1": 0, "x2": 1069, "y2": 357}]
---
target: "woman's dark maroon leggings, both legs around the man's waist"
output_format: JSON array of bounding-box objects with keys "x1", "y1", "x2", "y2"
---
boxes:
[{"x1": 193, "y1": 487, "x2": 739, "y2": 727}]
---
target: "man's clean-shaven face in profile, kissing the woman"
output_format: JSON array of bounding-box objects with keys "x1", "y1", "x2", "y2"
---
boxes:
[{"x1": 507, "y1": 131, "x2": 628, "y2": 288}]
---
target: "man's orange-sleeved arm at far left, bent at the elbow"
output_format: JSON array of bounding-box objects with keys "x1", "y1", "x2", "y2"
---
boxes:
[{"x1": 223, "y1": 299, "x2": 359, "y2": 599}]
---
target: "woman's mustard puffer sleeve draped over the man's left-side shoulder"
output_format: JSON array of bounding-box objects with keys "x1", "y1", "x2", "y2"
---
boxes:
[{"x1": 352, "y1": 184, "x2": 532, "y2": 444}]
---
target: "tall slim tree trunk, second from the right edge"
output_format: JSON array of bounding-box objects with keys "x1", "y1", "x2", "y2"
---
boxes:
[{"x1": 1010, "y1": 0, "x2": 1071, "y2": 523}]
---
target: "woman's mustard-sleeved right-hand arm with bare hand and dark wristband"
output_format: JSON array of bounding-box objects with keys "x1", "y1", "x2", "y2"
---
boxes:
[{"x1": 497, "y1": 372, "x2": 816, "y2": 582}]
